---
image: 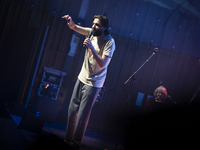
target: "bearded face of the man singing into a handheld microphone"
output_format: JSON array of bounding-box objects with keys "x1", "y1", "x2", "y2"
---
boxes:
[{"x1": 92, "y1": 18, "x2": 104, "y2": 36}]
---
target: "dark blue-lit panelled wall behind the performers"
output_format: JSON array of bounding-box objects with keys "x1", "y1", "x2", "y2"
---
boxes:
[{"x1": 0, "y1": 0, "x2": 200, "y2": 141}]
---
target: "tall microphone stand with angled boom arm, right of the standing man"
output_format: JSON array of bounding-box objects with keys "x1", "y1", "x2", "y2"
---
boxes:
[{"x1": 115, "y1": 48, "x2": 158, "y2": 150}]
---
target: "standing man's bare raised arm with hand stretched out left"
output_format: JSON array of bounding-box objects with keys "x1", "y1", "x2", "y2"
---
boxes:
[{"x1": 62, "y1": 15, "x2": 89, "y2": 36}]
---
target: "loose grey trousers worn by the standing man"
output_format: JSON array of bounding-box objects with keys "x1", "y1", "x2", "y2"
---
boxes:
[{"x1": 65, "y1": 80, "x2": 100, "y2": 147}]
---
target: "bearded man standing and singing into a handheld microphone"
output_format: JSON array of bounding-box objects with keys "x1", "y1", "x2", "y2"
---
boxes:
[{"x1": 62, "y1": 15, "x2": 115, "y2": 149}]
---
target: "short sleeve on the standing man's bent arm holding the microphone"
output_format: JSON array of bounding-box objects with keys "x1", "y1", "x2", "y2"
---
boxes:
[{"x1": 103, "y1": 39, "x2": 115, "y2": 57}]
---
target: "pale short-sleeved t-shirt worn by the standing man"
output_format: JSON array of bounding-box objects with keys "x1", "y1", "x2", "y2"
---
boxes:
[{"x1": 78, "y1": 28, "x2": 115, "y2": 88}]
